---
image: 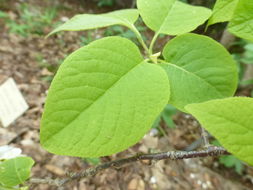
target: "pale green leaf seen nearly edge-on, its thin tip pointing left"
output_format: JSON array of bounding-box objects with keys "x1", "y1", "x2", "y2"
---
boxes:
[{"x1": 48, "y1": 9, "x2": 139, "y2": 36}]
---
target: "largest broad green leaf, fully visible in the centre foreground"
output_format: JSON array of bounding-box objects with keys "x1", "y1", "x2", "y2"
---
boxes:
[{"x1": 41, "y1": 37, "x2": 170, "y2": 157}]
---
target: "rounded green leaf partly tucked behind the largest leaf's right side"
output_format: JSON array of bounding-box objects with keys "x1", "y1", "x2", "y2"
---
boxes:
[{"x1": 161, "y1": 34, "x2": 238, "y2": 111}]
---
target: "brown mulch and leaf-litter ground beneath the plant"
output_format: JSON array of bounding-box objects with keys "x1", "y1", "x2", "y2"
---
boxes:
[{"x1": 0, "y1": 0, "x2": 253, "y2": 190}]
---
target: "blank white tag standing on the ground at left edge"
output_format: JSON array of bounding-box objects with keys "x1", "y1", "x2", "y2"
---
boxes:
[{"x1": 0, "y1": 78, "x2": 28, "y2": 127}]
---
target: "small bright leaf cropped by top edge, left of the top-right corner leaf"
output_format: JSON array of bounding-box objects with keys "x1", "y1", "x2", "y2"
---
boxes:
[{"x1": 208, "y1": 0, "x2": 239, "y2": 25}]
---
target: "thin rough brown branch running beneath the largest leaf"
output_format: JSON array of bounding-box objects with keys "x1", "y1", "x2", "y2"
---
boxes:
[{"x1": 29, "y1": 146, "x2": 230, "y2": 186}]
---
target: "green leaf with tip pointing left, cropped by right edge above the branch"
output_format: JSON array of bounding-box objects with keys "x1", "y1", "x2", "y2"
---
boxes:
[{"x1": 185, "y1": 97, "x2": 253, "y2": 165}]
